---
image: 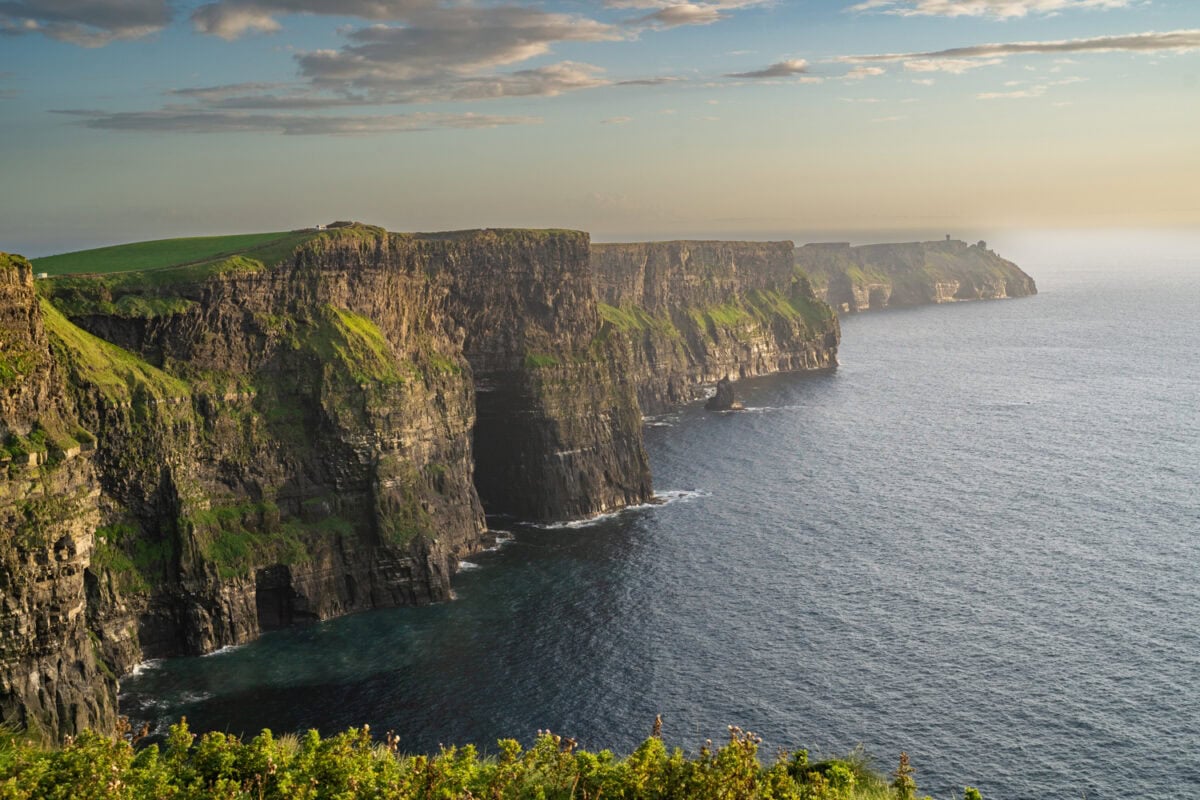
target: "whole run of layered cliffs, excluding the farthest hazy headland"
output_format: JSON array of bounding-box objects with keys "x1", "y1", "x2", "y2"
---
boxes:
[{"x1": 0, "y1": 224, "x2": 838, "y2": 738}]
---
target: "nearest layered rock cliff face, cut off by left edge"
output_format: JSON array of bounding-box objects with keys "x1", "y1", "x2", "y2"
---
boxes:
[{"x1": 0, "y1": 253, "x2": 116, "y2": 738}]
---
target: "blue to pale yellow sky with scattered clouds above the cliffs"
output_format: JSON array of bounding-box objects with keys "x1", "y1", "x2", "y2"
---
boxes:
[{"x1": 0, "y1": 0, "x2": 1200, "y2": 257}]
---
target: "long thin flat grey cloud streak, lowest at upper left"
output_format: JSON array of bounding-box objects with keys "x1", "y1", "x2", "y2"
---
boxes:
[{"x1": 55, "y1": 108, "x2": 541, "y2": 136}]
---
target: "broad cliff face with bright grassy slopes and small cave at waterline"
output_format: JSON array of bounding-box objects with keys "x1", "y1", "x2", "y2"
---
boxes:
[{"x1": 21, "y1": 229, "x2": 485, "y2": 695}]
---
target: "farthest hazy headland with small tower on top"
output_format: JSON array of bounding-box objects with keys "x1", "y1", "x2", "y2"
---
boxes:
[{"x1": 796, "y1": 240, "x2": 1038, "y2": 313}]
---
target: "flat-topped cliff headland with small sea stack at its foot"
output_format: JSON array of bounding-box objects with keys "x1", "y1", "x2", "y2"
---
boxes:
[{"x1": 592, "y1": 241, "x2": 840, "y2": 413}]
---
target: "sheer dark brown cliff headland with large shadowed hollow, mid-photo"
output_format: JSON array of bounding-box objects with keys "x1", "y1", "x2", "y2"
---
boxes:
[{"x1": 420, "y1": 231, "x2": 652, "y2": 521}]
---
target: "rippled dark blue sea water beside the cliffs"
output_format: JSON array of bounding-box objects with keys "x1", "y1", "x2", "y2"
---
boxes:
[{"x1": 122, "y1": 237, "x2": 1200, "y2": 800}]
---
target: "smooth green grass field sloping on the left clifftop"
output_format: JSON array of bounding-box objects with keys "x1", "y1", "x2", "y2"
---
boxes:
[{"x1": 34, "y1": 231, "x2": 297, "y2": 275}]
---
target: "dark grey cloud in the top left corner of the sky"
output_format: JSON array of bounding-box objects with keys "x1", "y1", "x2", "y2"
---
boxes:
[{"x1": 0, "y1": 0, "x2": 172, "y2": 47}]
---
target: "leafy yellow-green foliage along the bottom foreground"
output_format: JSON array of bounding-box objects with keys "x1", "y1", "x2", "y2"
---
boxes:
[{"x1": 0, "y1": 720, "x2": 979, "y2": 800}]
